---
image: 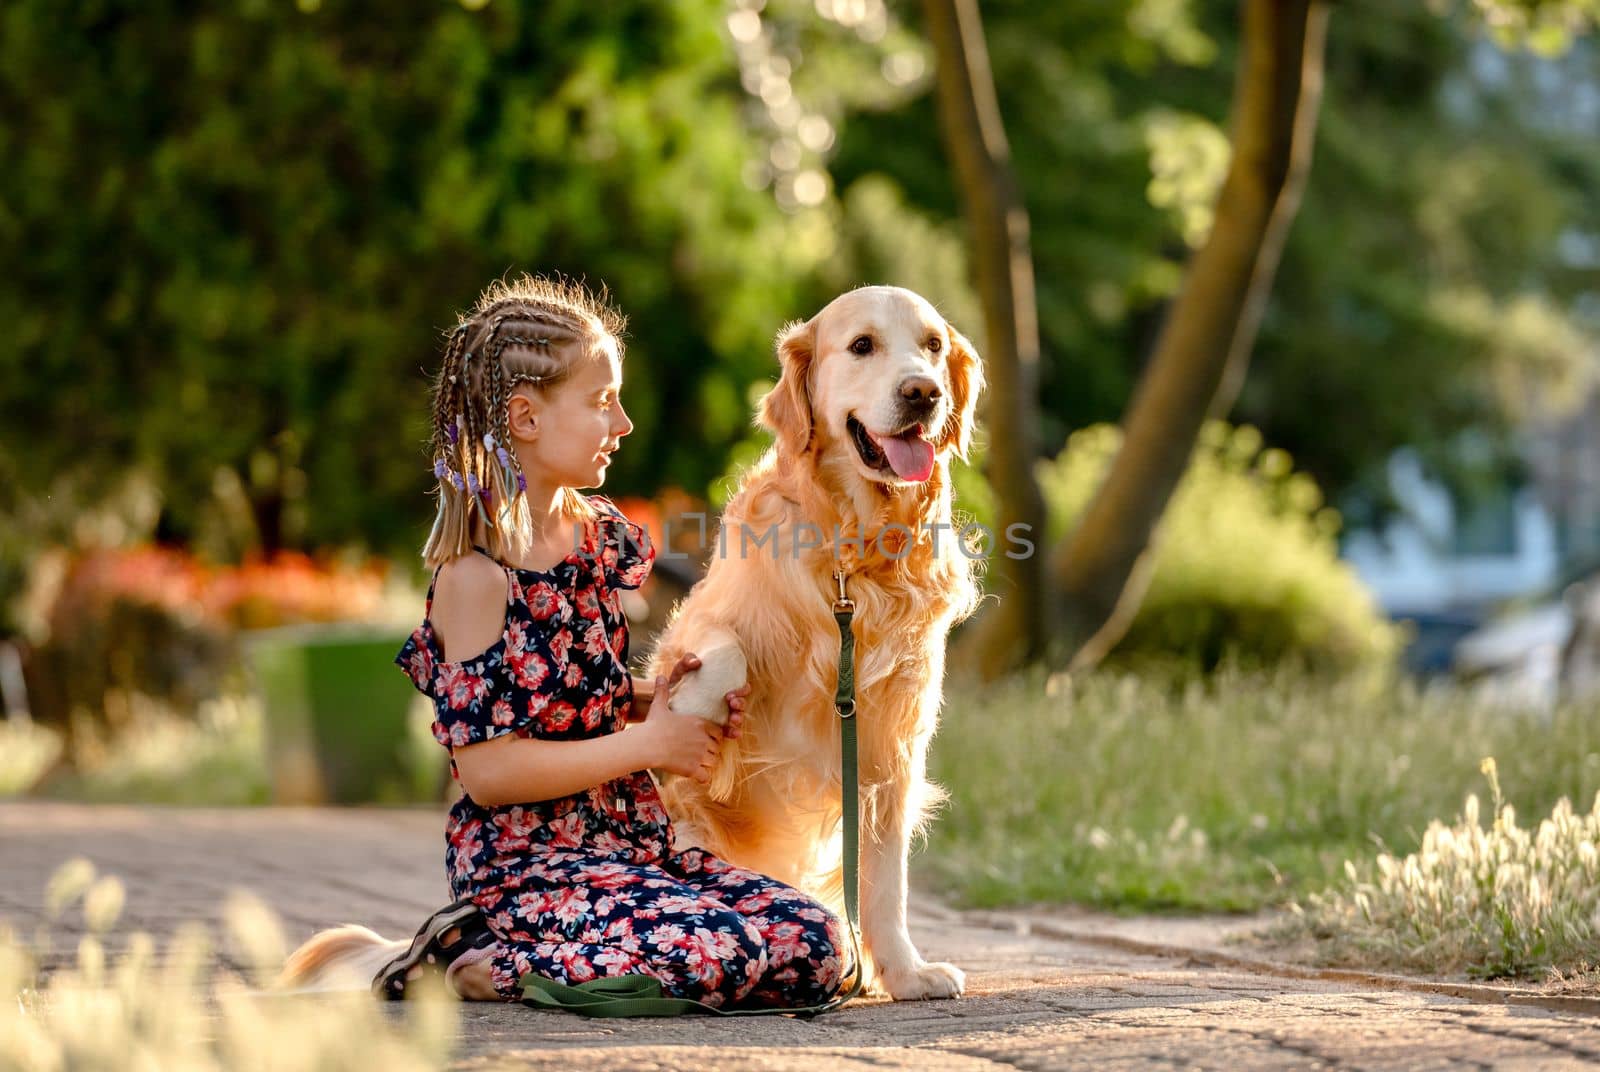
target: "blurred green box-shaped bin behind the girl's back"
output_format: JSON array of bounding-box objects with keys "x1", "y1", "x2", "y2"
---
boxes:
[{"x1": 245, "y1": 624, "x2": 418, "y2": 803}]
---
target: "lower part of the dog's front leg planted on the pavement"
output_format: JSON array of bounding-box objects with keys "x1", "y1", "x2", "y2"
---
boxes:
[{"x1": 861, "y1": 752, "x2": 966, "y2": 1002}]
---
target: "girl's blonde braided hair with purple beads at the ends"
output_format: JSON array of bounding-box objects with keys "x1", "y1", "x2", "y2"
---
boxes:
[{"x1": 422, "y1": 275, "x2": 627, "y2": 568}]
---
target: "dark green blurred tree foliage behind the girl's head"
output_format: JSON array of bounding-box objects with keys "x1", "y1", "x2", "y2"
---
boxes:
[{"x1": 0, "y1": 0, "x2": 857, "y2": 566}]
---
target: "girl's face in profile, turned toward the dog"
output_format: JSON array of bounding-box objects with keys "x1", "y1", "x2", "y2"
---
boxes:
[{"x1": 507, "y1": 336, "x2": 634, "y2": 491}]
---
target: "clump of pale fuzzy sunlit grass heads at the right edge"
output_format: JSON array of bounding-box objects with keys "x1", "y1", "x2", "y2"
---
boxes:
[{"x1": 1275, "y1": 758, "x2": 1600, "y2": 976}]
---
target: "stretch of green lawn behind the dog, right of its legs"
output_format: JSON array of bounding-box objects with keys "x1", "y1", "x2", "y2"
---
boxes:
[{"x1": 918, "y1": 670, "x2": 1600, "y2": 912}]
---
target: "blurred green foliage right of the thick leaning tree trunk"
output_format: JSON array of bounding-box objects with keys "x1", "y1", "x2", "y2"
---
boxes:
[{"x1": 1235, "y1": 10, "x2": 1600, "y2": 518}]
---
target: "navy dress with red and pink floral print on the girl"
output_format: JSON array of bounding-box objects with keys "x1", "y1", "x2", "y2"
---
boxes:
[{"x1": 395, "y1": 496, "x2": 848, "y2": 1008}]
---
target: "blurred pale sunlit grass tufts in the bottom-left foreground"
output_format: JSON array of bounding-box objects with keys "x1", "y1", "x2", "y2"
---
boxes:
[{"x1": 0, "y1": 859, "x2": 458, "y2": 1072}]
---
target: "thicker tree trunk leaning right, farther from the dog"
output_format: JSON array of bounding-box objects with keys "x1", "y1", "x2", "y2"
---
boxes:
[{"x1": 1051, "y1": 0, "x2": 1328, "y2": 667}]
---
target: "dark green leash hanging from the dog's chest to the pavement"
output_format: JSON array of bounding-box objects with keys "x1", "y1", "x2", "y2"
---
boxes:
[{"x1": 517, "y1": 570, "x2": 866, "y2": 1019}]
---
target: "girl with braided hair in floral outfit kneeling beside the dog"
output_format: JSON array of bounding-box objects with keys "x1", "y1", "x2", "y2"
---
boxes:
[{"x1": 374, "y1": 277, "x2": 845, "y2": 1006}]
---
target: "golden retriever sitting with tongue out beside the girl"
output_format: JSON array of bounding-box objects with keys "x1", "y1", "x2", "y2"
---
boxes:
[{"x1": 651, "y1": 286, "x2": 982, "y2": 1000}]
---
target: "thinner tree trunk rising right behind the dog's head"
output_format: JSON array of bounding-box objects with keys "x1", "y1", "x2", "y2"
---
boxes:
[{"x1": 923, "y1": 0, "x2": 1051, "y2": 675}]
